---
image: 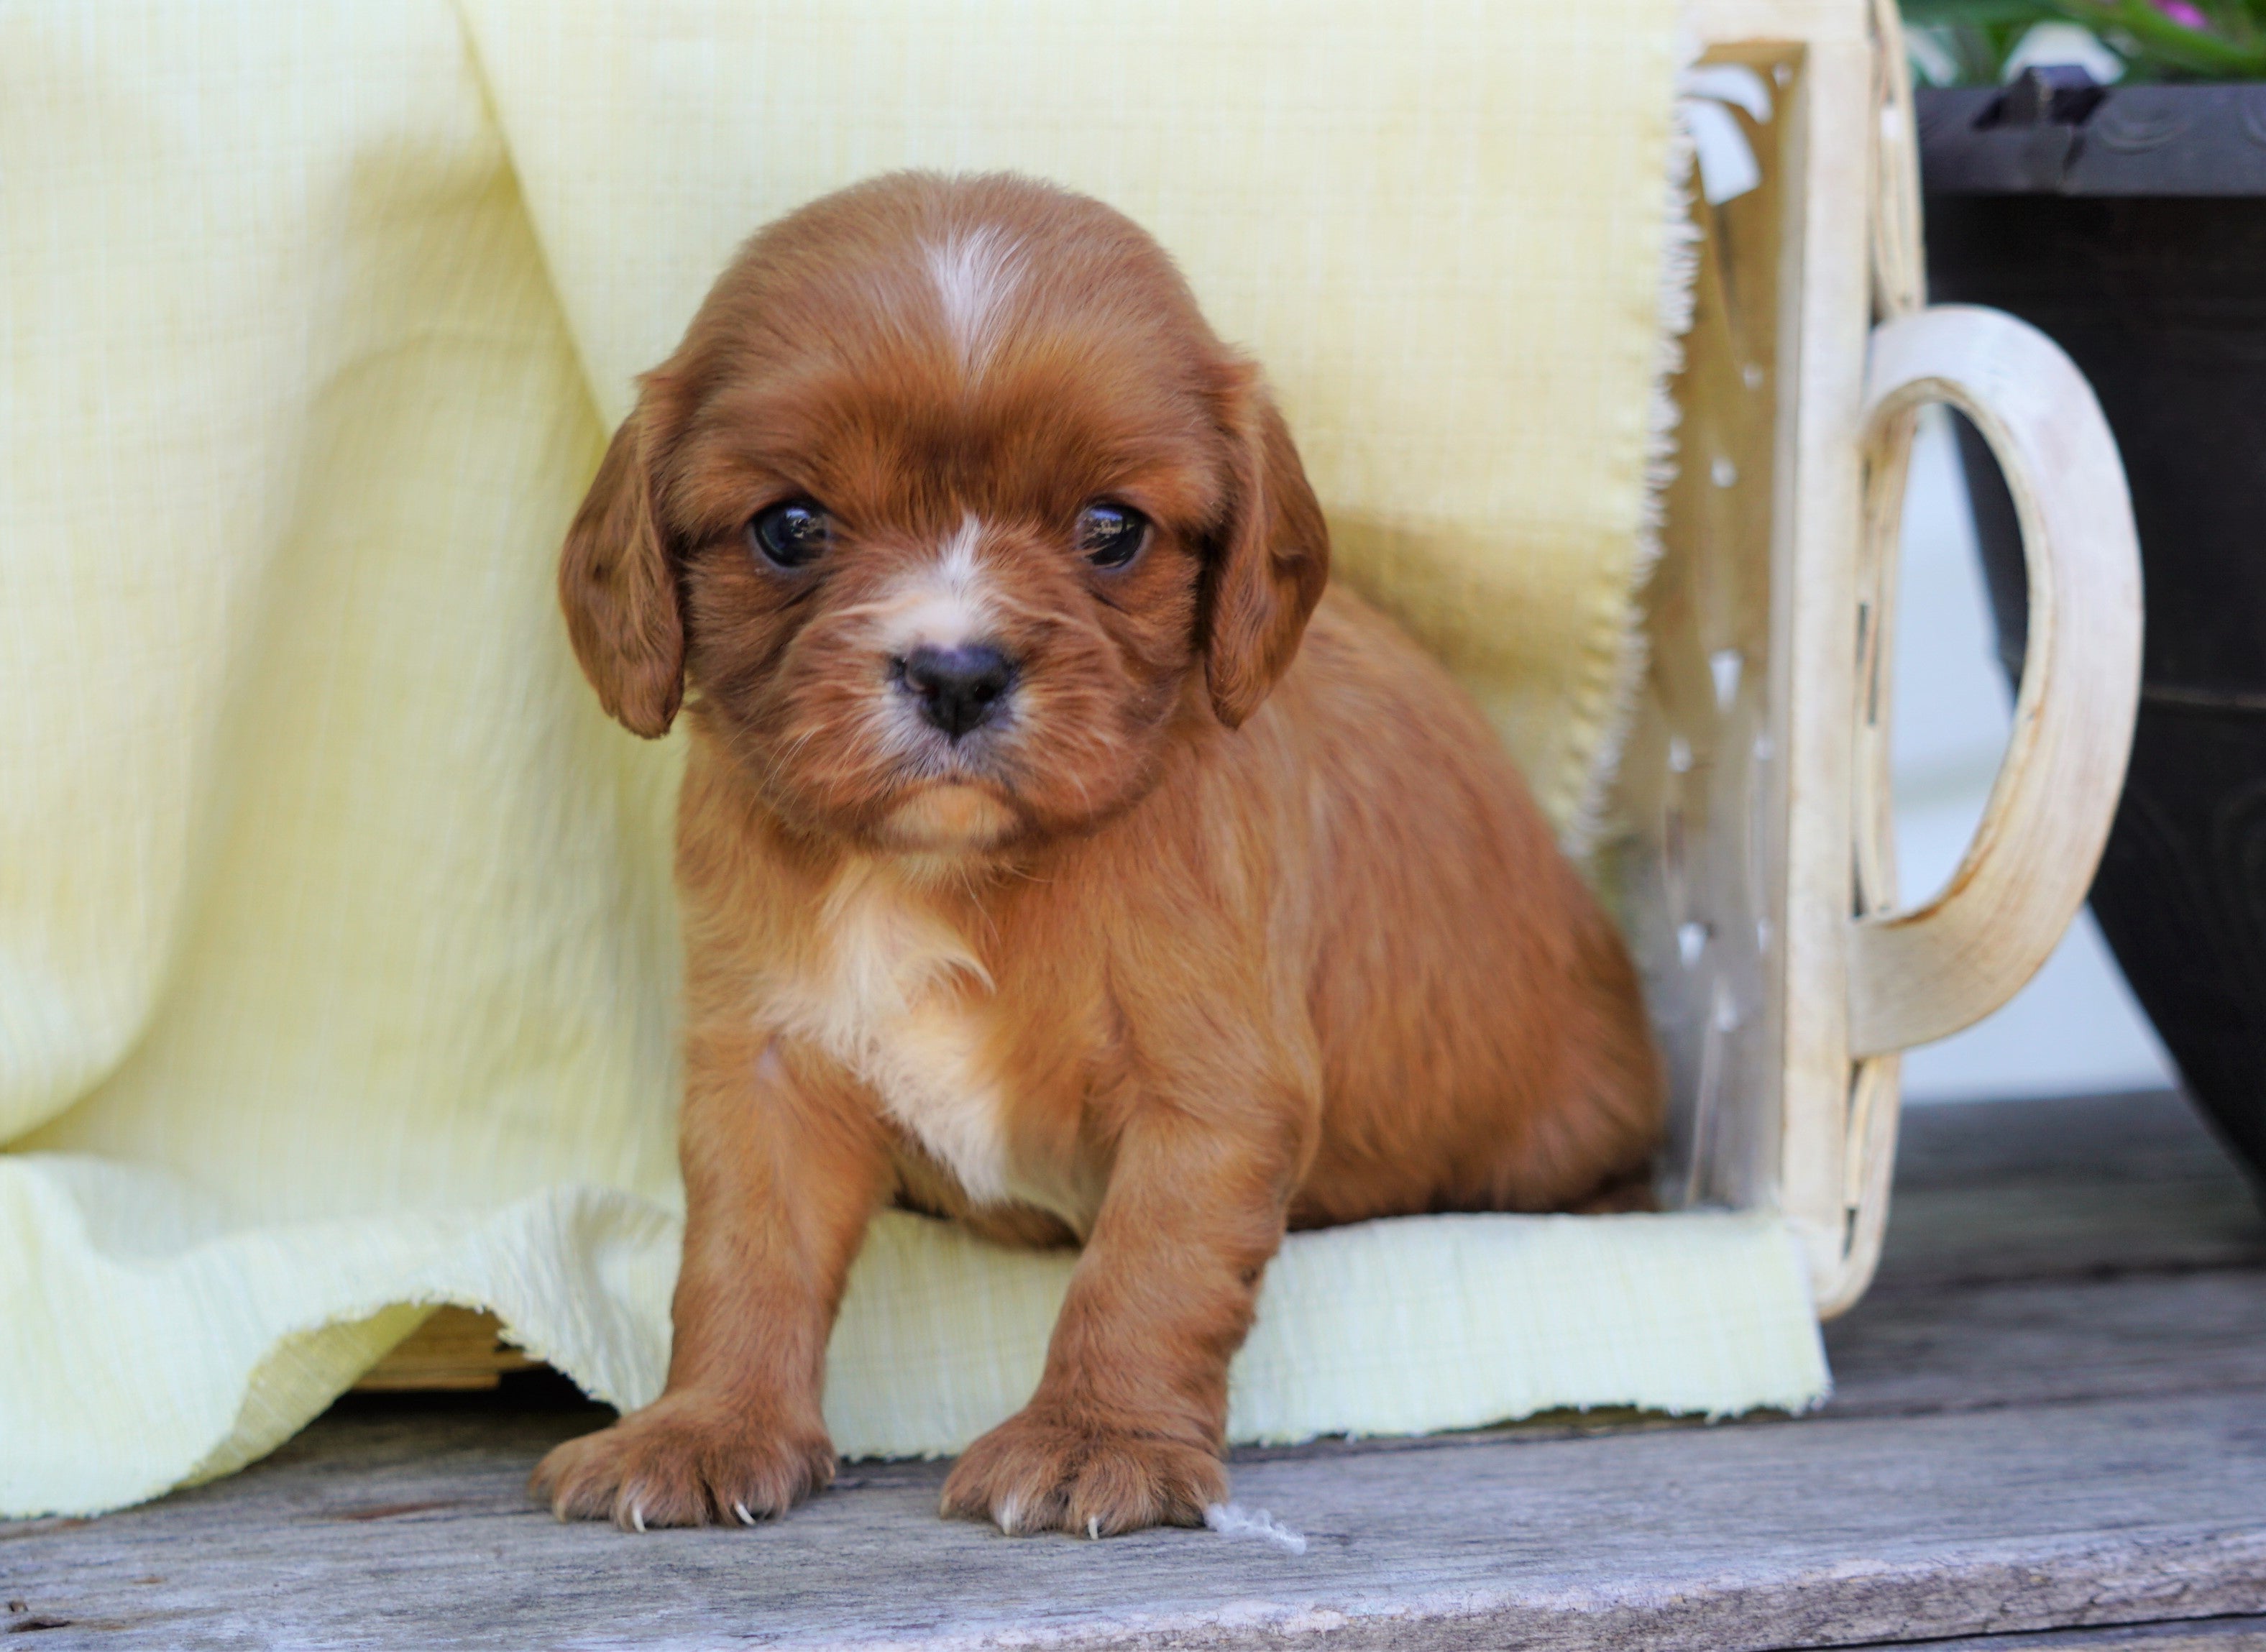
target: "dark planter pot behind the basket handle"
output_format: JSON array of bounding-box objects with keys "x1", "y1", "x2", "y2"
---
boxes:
[{"x1": 1919, "y1": 70, "x2": 2266, "y2": 1196}]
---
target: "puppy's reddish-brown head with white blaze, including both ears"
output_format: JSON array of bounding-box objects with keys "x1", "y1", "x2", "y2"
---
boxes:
[{"x1": 560, "y1": 175, "x2": 1328, "y2": 852}]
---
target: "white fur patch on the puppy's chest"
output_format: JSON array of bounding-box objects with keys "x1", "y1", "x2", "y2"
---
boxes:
[{"x1": 775, "y1": 859, "x2": 1011, "y2": 1203}]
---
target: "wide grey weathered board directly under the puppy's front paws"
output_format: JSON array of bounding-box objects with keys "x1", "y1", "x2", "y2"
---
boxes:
[{"x1": 0, "y1": 1396, "x2": 2266, "y2": 1652}]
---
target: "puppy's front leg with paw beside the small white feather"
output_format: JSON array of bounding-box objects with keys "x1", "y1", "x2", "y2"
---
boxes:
[{"x1": 942, "y1": 1106, "x2": 1296, "y2": 1536}]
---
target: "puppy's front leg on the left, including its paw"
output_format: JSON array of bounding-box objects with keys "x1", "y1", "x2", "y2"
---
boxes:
[{"x1": 531, "y1": 1029, "x2": 886, "y2": 1530}]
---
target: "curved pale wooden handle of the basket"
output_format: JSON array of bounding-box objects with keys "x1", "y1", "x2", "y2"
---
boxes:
[{"x1": 1849, "y1": 303, "x2": 2142, "y2": 1056}]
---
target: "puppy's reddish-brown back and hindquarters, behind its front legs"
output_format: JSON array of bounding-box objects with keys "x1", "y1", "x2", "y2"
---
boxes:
[{"x1": 1251, "y1": 587, "x2": 1661, "y2": 1226}]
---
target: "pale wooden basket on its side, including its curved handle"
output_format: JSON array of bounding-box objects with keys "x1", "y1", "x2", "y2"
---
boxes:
[{"x1": 362, "y1": 0, "x2": 2142, "y2": 1389}]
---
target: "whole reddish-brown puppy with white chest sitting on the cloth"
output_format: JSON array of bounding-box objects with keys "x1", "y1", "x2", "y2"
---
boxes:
[{"x1": 533, "y1": 175, "x2": 1661, "y2": 1536}]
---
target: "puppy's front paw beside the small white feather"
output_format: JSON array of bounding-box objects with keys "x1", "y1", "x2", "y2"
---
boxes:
[{"x1": 942, "y1": 1405, "x2": 1228, "y2": 1536}]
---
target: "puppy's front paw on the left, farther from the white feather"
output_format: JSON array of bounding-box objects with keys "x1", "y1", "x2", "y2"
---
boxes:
[{"x1": 528, "y1": 1394, "x2": 834, "y2": 1532}]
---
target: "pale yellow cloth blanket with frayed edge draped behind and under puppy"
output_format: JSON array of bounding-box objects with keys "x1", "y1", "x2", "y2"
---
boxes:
[{"x1": 0, "y1": 0, "x2": 1824, "y2": 1514}]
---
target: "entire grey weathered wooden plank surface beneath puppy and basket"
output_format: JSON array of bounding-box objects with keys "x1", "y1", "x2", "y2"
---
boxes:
[{"x1": 0, "y1": 1099, "x2": 2266, "y2": 1652}]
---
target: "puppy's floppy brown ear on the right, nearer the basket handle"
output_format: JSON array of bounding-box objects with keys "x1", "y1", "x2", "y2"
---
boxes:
[{"x1": 1203, "y1": 362, "x2": 1330, "y2": 728}]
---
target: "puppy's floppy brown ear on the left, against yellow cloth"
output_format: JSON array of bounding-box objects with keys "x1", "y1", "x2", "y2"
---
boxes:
[{"x1": 560, "y1": 385, "x2": 684, "y2": 739}]
